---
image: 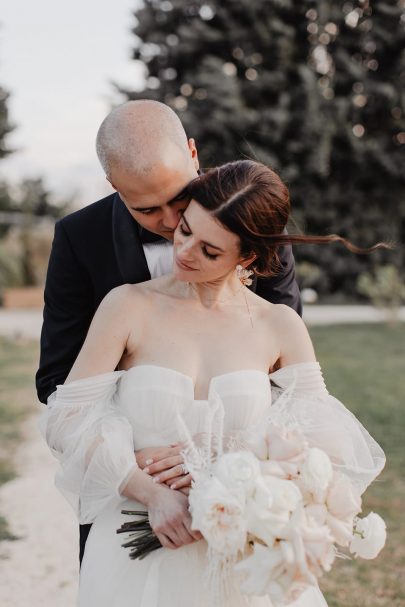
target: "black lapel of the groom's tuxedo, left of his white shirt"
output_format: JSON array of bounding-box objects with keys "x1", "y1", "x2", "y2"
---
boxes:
[{"x1": 112, "y1": 194, "x2": 151, "y2": 283}]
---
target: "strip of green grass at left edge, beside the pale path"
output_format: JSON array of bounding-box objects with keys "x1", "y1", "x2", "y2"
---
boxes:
[{"x1": 0, "y1": 339, "x2": 38, "y2": 540}]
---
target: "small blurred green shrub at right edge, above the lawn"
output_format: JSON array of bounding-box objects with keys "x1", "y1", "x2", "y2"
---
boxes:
[{"x1": 357, "y1": 265, "x2": 405, "y2": 320}]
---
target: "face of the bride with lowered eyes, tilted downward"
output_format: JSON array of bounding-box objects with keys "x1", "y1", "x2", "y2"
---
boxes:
[{"x1": 173, "y1": 200, "x2": 241, "y2": 282}]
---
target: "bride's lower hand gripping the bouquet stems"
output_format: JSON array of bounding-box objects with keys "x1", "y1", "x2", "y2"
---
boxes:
[{"x1": 148, "y1": 488, "x2": 202, "y2": 548}]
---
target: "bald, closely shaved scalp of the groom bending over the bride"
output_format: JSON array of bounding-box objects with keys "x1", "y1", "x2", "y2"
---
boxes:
[{"x1": 96, "y1": 99, "x2": 188, "y2": 178}]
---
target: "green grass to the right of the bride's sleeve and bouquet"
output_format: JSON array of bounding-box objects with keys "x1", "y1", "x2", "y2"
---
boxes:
[{"x1": 311, "y1": 324, "x2": 405, "y2": 607}]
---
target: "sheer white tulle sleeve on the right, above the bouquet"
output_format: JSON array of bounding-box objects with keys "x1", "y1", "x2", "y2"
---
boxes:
[{"x1": 270, "y1": 362, "x2": 385, "y2": 493}]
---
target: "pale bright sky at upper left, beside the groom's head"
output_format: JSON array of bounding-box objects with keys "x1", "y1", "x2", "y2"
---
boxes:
[{"x1": 0, "y1": 0, "x2": 143, "y2": 206}]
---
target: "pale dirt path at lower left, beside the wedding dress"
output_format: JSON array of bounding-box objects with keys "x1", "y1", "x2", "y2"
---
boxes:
[{"x1": 0, "y1": 415, "x2": 78, "y2": 607}]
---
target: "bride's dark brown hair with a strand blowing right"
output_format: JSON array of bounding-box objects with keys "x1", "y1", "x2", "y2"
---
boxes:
[{"x1": 187, "y1": 160, "x2": 390, "y2": 276}]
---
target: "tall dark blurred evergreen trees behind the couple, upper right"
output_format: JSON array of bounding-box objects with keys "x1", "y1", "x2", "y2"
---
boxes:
[{"x1": 120, "y1": 0, "x2": 405, "y2": 295}]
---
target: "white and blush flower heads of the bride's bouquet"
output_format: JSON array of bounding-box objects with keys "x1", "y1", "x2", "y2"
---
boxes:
[{"x1": 179, "y1": 392, "x2": 386, "y2": 605}]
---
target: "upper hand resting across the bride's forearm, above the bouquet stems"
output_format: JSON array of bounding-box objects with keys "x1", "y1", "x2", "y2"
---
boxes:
[{"x1": 136, "y1": 444, "x2": 191, "y2": 490}]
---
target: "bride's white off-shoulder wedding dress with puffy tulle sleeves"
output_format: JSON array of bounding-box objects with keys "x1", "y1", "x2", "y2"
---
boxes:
[{"x1": 41, "y1": 363, "x2": 385, "y2": 607}]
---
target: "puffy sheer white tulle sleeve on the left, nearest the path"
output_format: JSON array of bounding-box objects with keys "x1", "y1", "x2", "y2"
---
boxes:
[{"x1": 39, "y1": 371, "x2": 137, "y2": 524}]
